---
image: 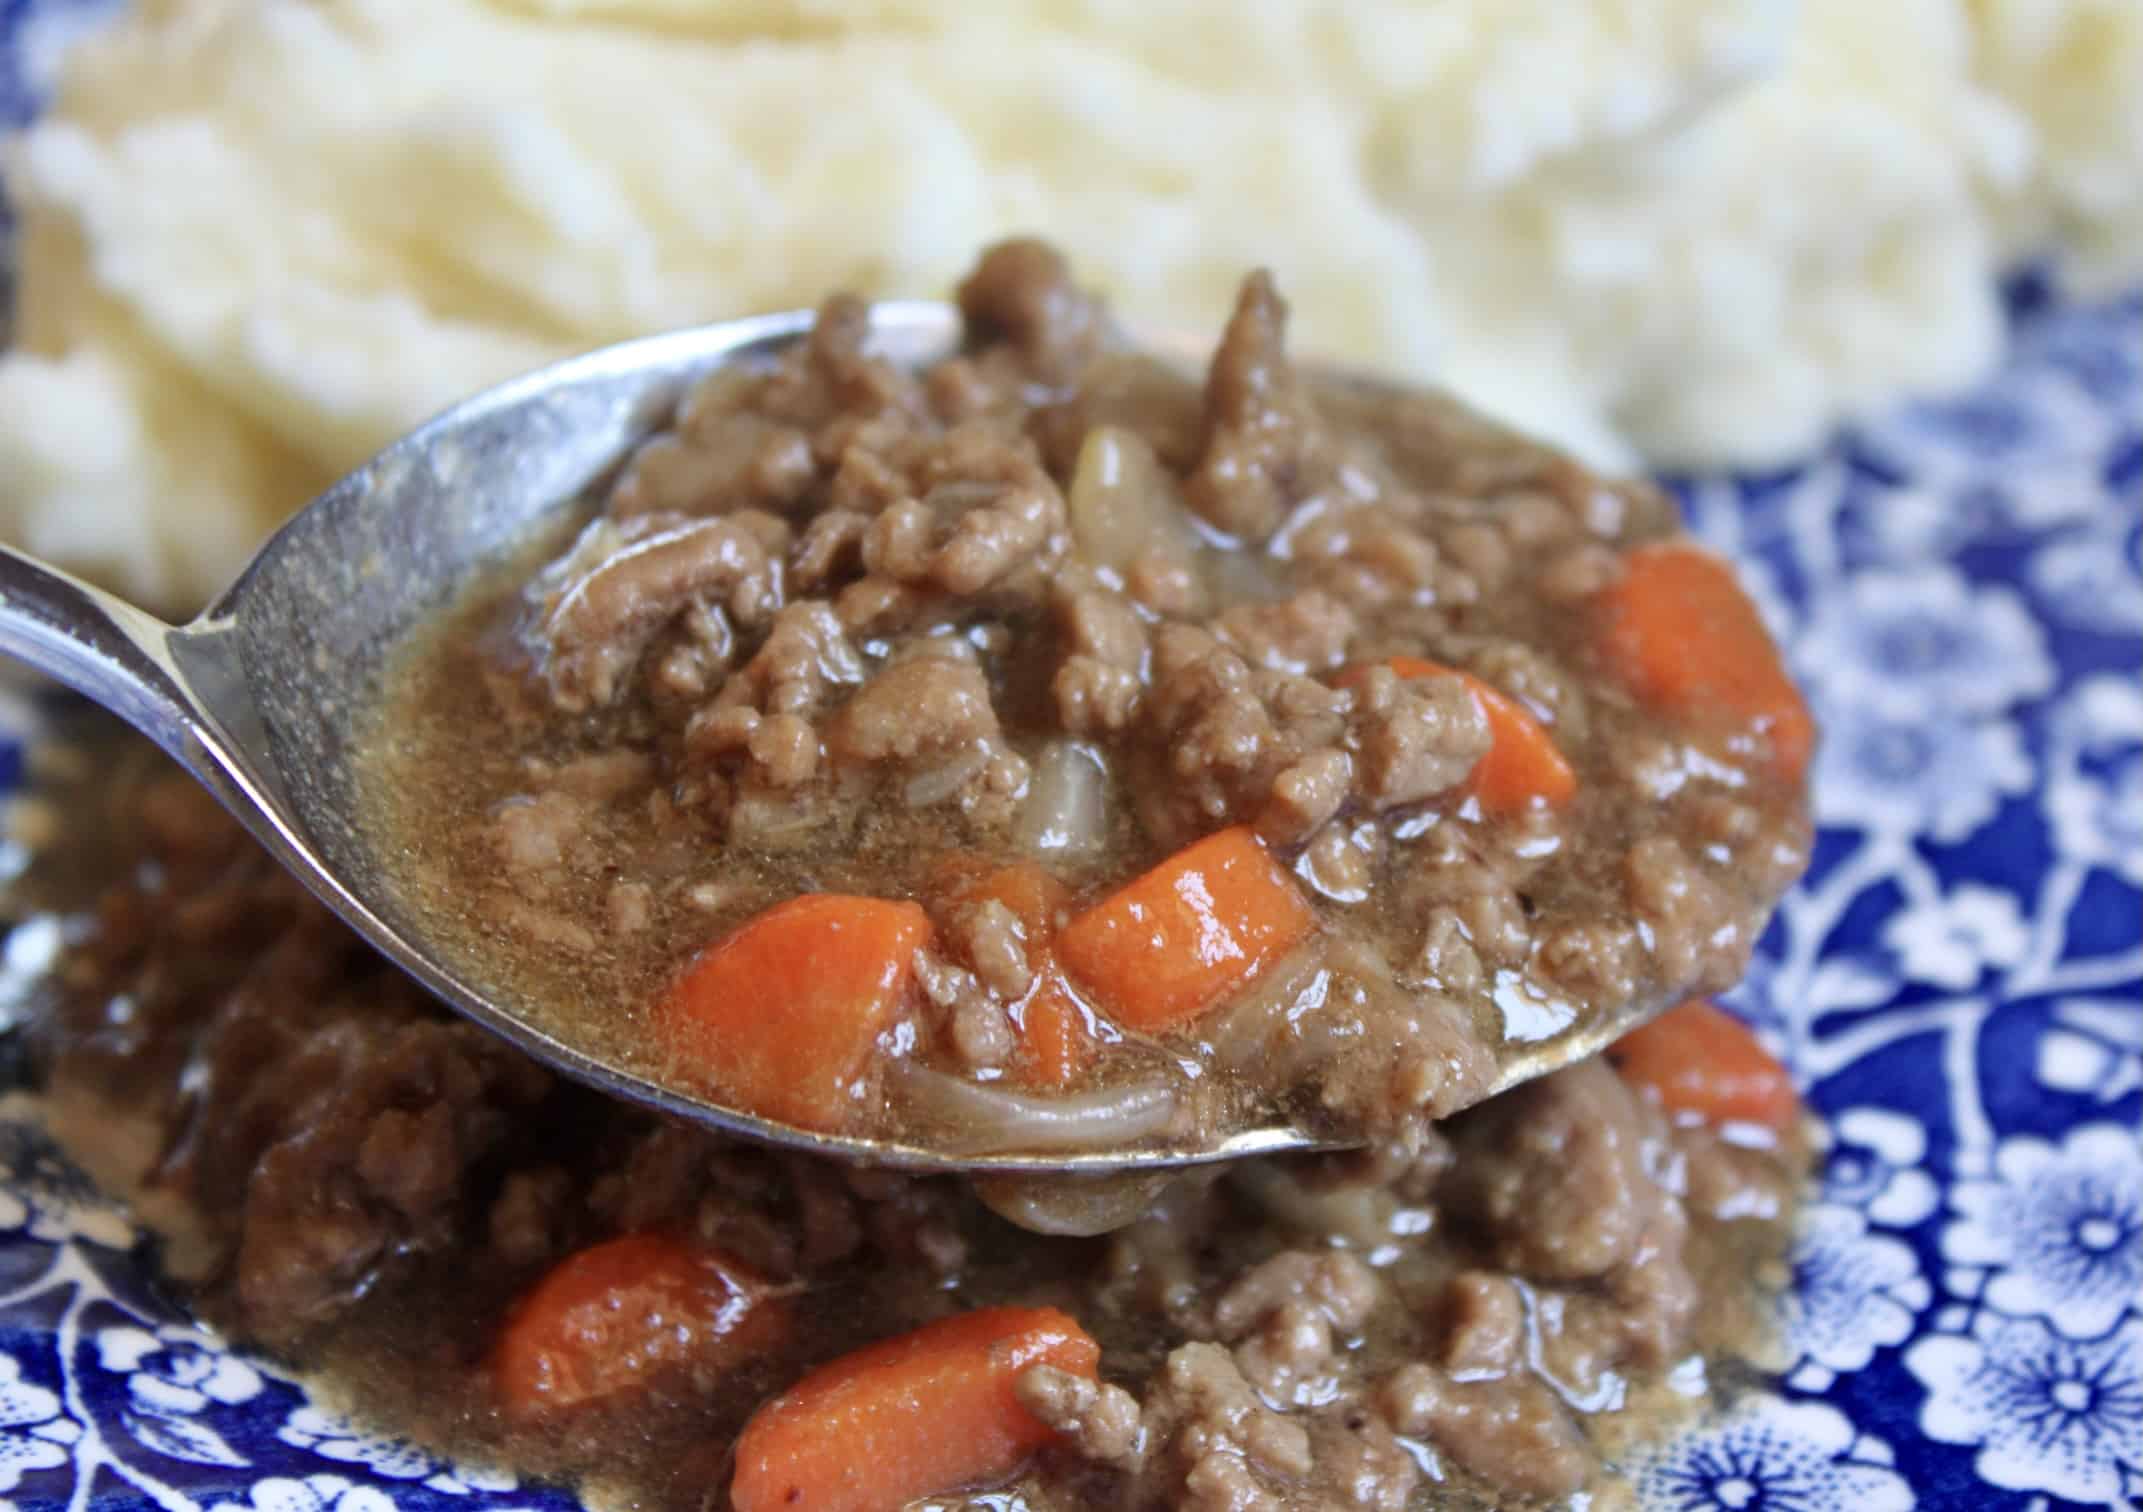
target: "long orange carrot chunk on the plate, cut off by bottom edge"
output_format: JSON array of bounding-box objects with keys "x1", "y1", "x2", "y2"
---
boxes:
[{"x1": 729, "y1": 1306, "x2": 1102, "y2": 1512}]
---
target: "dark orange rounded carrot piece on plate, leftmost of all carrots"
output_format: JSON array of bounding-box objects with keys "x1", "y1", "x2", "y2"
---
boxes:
[{"x1": 491, "y1": 1234, "x2": 786, "y2": 1413}]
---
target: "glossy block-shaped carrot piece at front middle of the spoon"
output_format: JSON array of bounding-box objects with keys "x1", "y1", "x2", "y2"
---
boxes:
[{"x1": 1056, "y1": 825, "x2": 1316, "y2": 1032}]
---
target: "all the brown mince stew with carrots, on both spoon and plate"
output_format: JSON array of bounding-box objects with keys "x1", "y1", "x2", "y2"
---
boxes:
[{"x1": 8, "y1": 242, "x2": 1811, "y2": 1512}]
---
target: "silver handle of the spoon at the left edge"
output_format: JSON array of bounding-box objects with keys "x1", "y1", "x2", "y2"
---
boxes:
[{"x1": 0, "y1": 546, "x2": 199, "y2": 767}]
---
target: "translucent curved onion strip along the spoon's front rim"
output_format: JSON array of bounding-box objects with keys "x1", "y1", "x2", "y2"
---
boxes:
[{"x1": 894, "y1": 1062, "x2": 1179, "y2": 1154}]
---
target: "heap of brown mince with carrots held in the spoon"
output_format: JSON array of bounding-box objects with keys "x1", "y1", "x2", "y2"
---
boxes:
[{"x1": 366, "y1": 242, "x2": 1811, "y2": 1150}]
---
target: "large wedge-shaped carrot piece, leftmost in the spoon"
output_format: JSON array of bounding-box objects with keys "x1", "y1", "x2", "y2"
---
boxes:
[{"x1": 660, "y1": 893, "x2": 930, "y2": 1129}]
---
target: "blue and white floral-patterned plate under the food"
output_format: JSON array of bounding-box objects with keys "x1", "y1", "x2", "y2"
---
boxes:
[{"x1": 0, "y1": 0, "x2": 2143, "y2": 1512}]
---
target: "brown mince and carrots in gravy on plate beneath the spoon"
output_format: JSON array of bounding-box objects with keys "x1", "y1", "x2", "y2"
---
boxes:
[{"x1": 32, "y1": 766, "x2": 1800, "y2": 1512}]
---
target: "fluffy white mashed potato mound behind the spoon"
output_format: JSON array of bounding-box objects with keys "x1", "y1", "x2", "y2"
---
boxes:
[{"x1": 0, "y1": 0, "x2": 2143, "y2": 606}]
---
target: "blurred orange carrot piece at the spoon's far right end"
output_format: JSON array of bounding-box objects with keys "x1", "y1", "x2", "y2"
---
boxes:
[{"x1": 1599, "y1": 542, "x2": 1815, "y2": 782}]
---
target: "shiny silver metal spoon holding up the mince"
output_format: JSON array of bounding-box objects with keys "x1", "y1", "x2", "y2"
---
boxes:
[{"x1": 0, "y1": 302, "x2": 1659, "y2": 1178}]
